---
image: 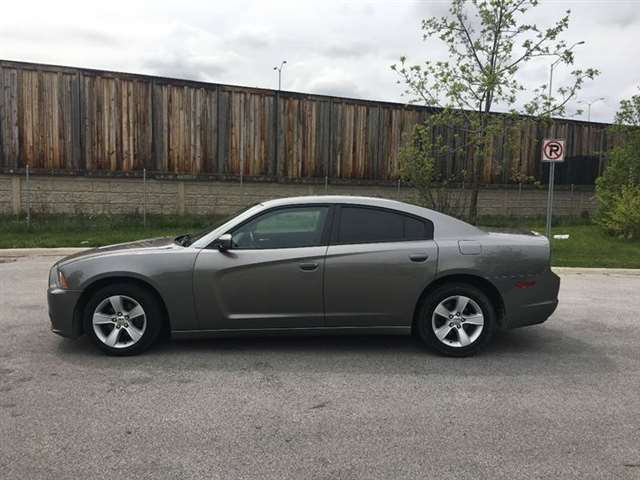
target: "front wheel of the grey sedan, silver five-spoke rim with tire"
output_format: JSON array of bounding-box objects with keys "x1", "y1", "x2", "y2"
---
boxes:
[{"x1": 84, "y1": 283, "x2": 163, "y2": 355}]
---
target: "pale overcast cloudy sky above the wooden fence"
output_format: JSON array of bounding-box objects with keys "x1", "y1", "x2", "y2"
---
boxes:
[{"x1": 0, "y1": 0, "x2": 640, "y2": 122}]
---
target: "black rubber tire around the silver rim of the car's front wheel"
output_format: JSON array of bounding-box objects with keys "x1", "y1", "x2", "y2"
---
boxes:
[{"x1": 83, "y1": 282, "x2": 164, "y2": 356}]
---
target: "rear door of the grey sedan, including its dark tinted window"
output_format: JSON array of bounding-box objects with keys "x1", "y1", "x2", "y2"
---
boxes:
[{"x1": 325, "y1": 205, "x2": 438, "y2": 327}]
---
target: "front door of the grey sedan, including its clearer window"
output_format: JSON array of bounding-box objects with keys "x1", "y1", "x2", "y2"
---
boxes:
[{"x1": 194, "y1": 205, "x2": 329, "y2": 330}]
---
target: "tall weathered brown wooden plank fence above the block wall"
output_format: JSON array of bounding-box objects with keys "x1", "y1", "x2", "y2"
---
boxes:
[{"x1": 0, "y1": 60, "x2": 607, "y2": 184}]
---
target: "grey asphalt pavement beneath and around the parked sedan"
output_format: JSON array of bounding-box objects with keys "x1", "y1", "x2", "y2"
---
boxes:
[{"x1": 0, "y1": 253, "x2": 640, "y2": 479}]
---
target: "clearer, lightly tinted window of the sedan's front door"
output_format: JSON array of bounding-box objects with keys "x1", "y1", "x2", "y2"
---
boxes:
[{"x1": 232, "y1": 207, "x2": 329, "y2": 249}]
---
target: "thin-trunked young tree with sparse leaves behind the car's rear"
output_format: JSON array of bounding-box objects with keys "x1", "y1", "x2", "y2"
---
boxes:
[{"x1": 391, "y1": 0, "x2": 599, "y2": 222}]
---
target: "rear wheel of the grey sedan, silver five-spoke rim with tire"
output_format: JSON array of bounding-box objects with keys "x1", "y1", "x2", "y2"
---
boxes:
[{"x1": 416, "y1": 284, "x2": 496, "y2": 357}]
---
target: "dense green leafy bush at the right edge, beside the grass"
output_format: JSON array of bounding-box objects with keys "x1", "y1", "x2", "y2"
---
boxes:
[{"x1": 596, "y1": 95, "x2": 640, "y2": 238}]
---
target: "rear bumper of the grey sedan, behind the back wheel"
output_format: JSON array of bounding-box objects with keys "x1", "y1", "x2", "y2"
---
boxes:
[{"x1": 502, "y1": 270, "x2": 560, "y2": 328}]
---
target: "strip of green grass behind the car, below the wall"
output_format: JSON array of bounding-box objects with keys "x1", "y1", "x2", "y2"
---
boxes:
[{"x1": 0, "y1": 215, "x2": 640, "y2": 268}]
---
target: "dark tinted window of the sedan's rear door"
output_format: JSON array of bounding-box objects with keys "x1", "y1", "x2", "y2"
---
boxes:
[{"x1": 337, "y1": 207, "x2": 433, "y2": 244}]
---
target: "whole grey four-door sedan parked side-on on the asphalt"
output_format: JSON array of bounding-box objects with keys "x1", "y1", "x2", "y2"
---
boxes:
[{"x1": 48, "y1": 196, "x2": 560, "y2": 356}]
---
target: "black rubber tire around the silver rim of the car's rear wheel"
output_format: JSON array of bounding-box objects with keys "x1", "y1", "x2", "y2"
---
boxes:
[{"x1": 415, "y1": 283, "x2": 497, "y2": 357}]
